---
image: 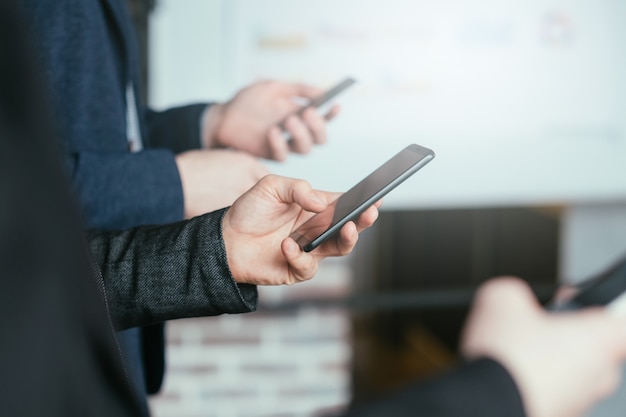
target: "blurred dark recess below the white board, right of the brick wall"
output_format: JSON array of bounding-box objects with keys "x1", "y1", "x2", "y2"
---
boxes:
[{"x1": 351, "y1": 208, "x2": 560, "y2": 405}]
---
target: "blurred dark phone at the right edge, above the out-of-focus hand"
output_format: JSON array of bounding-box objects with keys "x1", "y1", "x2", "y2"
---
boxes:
[{"x1": 548, "y1": 252, "x2": 626, "y2": 315}]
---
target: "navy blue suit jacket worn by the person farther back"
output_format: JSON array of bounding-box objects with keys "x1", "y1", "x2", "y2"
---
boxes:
[{"x1": 20, "y1": 0, "x2": 206, "y2": 400}]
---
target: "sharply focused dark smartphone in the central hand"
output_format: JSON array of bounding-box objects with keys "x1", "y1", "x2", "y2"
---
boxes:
[{"x1": 290, "y1": 144, "x2": 435, "y2": 252}]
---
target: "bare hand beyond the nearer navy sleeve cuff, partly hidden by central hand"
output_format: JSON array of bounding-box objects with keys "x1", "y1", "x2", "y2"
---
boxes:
[{"x1": 176, "y1": 149, "x2": 269, "y2": 219}]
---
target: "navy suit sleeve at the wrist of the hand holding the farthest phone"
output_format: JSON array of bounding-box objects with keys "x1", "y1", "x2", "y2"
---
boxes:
[{"x1": 144, "y1": 103, "x2": 210, "y2": 153}]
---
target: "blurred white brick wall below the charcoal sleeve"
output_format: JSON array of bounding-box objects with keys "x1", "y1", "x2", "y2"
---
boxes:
[{"x1": 150, "y1": 259, "x2": 351, "y2": 417}]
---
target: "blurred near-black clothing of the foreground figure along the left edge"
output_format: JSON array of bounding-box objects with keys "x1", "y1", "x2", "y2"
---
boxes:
[{"x1": 0, "y1": 0, "x2": 137, "y2": 417}]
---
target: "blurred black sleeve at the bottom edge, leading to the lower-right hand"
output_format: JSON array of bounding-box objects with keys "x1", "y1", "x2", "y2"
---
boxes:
[{"x1": 342, "y1": 359, "x2": 525, "y2": 417}]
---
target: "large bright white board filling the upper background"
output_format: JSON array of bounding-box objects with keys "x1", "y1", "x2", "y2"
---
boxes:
[{"x1": 151, "y1": 0, "x2": 626, "y2": 208}]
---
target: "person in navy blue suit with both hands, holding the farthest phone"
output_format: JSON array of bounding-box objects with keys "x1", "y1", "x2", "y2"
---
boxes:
[{"x1": 20, "y1": 0, "x2": 337, "y2": 407}]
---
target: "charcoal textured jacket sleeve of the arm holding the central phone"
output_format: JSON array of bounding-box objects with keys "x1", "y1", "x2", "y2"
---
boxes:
[{"x1": 87, "y1": 209, "x2": 258, "y2": 330}]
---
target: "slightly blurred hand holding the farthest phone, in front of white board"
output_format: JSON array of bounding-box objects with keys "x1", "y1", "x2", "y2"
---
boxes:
[{"x1": 202, "y1": 81, "x2": 339, "y2": 161}]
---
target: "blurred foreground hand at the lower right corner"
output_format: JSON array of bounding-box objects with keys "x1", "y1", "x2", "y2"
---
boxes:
[{"x1": 462, "y1": 278, "x2": 626, "y2": 417}]
